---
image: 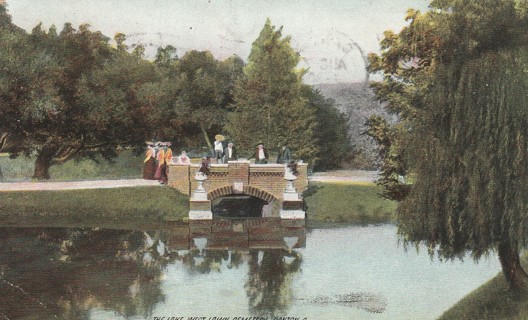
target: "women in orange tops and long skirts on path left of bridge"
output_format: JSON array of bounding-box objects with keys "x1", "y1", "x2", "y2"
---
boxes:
[{"x1": 143, "y1": 142, "x2": 172, "y2": 184}]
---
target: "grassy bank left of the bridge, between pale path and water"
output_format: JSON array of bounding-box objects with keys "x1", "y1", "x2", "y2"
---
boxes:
[{"x1": 0, "y1": 187, "x2": 189, "y2": 223}]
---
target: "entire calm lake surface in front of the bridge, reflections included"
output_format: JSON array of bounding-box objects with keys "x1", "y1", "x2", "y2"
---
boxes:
[{"x1": 0, "y1": 219, "x2": 500, "y2": 320}]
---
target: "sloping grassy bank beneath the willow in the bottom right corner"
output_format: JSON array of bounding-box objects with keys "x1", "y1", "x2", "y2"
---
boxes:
[{"x1": 439, "y1": 255, "x2": 528, "y2": 320}]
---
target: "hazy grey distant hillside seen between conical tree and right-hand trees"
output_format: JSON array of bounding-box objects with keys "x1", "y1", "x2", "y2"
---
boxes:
[{"x1": 313, "y1": 82, "x2": 394, "y2": 168}]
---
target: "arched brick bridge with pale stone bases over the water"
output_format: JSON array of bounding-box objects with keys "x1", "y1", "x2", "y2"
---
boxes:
[{"x1": 168, "y1": 160, "x2": 308, "y2": 220}]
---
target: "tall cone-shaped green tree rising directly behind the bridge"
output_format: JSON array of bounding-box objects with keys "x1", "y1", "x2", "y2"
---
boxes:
[{"x1": 227, "y1": 19, "x2": 317, "y2": 160}]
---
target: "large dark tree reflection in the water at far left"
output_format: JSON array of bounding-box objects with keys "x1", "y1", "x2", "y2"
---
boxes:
[{"x1": 0, "y1": 228, "x2": 171, "y2": 319}]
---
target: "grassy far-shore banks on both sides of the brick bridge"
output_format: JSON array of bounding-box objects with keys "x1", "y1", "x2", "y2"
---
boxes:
[{"x1": 0, "y1": 183, "x2": 395, "y2": 225}]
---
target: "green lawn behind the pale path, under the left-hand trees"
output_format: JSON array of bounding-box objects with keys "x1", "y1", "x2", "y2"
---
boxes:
[{"x1": 0, "y1": 150, "x2": 143, "y2": 182}]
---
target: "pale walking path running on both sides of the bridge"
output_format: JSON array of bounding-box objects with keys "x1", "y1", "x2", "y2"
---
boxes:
[{"x1": 0, "y1": 170, "x2": 378, "y2": 191}]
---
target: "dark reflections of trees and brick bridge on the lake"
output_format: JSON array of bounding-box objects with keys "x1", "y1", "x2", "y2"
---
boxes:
[{"x1": 0, "y1": 219, "x2": 306, "y2": 319}]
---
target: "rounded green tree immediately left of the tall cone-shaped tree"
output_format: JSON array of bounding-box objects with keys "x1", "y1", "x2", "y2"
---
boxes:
[{"x1": 151, "y1": 50, "x2": 243, "y2": 153}]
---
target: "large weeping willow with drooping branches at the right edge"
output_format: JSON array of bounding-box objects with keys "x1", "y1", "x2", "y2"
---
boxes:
[{"x1": 398, "y1": 48, "x2": 528, "y2": 288}]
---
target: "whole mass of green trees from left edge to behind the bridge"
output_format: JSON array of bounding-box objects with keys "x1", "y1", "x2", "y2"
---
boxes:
[{"x1": 0, "y1": 5, "x2": 349, "y2": 179}]
